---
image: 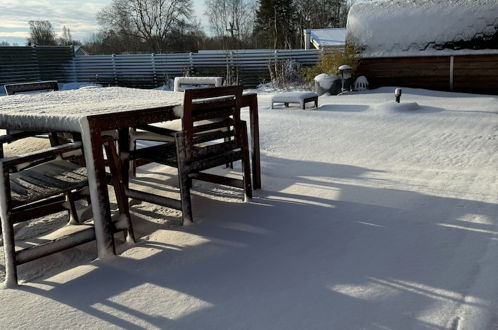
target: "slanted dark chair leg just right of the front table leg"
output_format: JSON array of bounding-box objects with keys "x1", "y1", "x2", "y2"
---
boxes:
[{"x1": 104, "y1": 141, "x2": 135, "y2": 242}]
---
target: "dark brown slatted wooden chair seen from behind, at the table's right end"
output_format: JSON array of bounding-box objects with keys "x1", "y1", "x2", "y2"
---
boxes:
[{"x1": 126, "y1": 86, "x2": 252, "y2": 223}]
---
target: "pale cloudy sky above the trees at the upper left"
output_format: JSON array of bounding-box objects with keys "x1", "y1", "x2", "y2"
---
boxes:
[{"x1": 0, "y1": 0, "x2": 206, "y2": 46}]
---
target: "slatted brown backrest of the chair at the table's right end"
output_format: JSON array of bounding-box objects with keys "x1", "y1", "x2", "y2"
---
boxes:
[{"x1": 182, "y1": 86, "x2": 242, "y2": 158}]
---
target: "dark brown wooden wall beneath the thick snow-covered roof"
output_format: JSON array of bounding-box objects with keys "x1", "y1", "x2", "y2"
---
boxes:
[{"x1": 357, "y1": 54, "x2": 498, "y2": 95}]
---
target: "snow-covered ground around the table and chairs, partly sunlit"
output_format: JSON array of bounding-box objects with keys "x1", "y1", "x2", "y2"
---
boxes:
[{"x1": 0, "y1": 88, "x2": 498, "y2": 329}]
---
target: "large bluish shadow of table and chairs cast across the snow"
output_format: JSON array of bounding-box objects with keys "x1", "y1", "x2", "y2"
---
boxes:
[{"x1": 9, "y1": 157, "x2": 498, "y2": 329}]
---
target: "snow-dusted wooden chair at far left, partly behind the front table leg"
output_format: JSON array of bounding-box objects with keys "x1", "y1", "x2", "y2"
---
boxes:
[{"x1": 0, "y1": 138, "x2": 134, "y2": 286}]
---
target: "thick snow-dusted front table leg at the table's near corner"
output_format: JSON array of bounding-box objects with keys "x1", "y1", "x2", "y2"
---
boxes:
[{"x1": 82, "y1": 122, "x2": 116, "y2": 259}]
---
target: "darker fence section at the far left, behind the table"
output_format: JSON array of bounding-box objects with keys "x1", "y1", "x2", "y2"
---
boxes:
[{"x1": 0, "y1": 47, "x2": 74, "y2": 85}]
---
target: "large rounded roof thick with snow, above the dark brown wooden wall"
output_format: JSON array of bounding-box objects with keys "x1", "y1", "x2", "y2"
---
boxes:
[{"x1": 347, "y1": 0, "x2": 498, "y2": 57}]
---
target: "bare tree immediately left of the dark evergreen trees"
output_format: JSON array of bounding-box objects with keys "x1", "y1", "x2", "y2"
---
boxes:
[{"x1": 205, "y1": 0, "x2": 256, "y2": 47}]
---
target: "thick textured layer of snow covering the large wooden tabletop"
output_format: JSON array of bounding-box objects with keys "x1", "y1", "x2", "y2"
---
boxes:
[{"x1": 0, "y1": 87, "x2": 184, "y2": 131}]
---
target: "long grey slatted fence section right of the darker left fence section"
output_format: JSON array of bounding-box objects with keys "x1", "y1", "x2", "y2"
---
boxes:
[{"x1": 71, "y1": 49, "x2": 320, "y2": 87}]
